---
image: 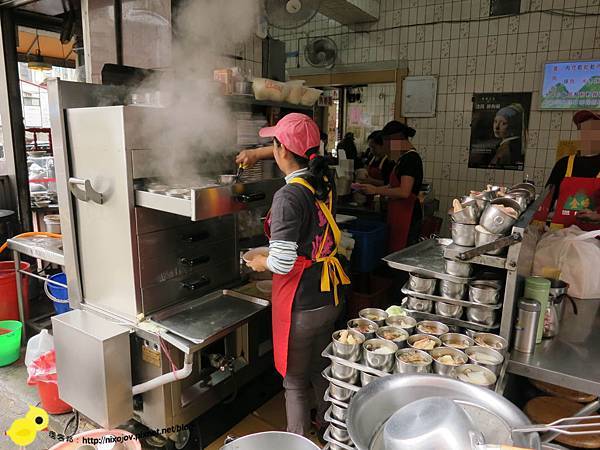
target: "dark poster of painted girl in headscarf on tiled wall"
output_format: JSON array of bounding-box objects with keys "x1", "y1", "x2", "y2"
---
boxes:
[{"x1": 469, "y1": 92, "x2": 531, "y2": 170}]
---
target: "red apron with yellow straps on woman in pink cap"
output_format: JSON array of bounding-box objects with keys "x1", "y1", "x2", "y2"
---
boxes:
[{"x1": 265, "y1": 178, "x2": 350, "y2": 377}]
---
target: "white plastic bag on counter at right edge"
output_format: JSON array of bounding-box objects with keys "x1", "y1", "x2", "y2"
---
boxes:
[{"x1": 533, "y1": 226, "x2": 600, "y2": 299}]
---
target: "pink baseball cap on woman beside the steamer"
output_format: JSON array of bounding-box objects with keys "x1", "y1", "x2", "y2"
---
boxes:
[{"x1": 258, "y1": 113, "x2": 321, "y2": 156}]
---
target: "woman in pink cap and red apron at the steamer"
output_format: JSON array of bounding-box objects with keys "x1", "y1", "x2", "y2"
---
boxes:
[{"x1": 236, "y1": 113, "x2": 350, "y2": 436}]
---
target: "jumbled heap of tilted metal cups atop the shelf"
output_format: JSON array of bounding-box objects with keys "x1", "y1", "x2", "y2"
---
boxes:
[{"x1": 449, "y1": 183, "x2": 536, "y2": 255}]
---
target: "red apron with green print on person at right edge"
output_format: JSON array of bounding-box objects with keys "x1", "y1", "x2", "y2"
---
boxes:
[{"x1": 550, "y1": 155, "x2": 600, "y2": 231}]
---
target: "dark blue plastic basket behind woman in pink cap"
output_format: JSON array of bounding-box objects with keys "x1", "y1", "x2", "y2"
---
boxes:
[{"x1": 343, "y1": 219, "x2": 387, "y2": 272}]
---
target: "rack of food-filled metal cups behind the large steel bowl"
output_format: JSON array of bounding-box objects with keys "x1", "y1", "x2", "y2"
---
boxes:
[{"x1": 322, "y1": 308, "x2": 508, "y2": 450}]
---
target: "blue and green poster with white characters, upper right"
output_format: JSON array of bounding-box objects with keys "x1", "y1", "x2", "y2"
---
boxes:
[{"x1": 540, "y1": 60, "x2": 600, "y2": 109}]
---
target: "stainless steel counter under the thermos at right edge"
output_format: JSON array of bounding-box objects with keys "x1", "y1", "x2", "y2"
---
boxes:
[{"x1": 508, "y1": 308, "x2": 600, "y2": 395}]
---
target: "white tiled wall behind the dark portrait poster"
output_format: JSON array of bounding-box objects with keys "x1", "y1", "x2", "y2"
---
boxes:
[{"x1": 273, "y1": 0, "x2": 600, "y2": 218}]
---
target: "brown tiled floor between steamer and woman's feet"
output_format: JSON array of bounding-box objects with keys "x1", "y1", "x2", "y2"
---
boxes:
[{"x1": 207, "y1": 392, "x2": 326, "y2": 450}]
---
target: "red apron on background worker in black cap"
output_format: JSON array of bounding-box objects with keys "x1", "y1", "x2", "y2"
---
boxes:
[{"x1": 387, "y1": 150, "x2": 417, "y2": 253}]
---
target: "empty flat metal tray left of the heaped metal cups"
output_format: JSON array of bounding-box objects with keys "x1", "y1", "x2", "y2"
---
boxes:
[{"x1": 383, "y1": 239, "x2": 471, "y2": 283}]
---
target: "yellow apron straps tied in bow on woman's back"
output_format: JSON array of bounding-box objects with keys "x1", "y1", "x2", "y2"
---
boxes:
[{"x1": 290, "y1": 177, "x2": 350, "y2": 306}]
